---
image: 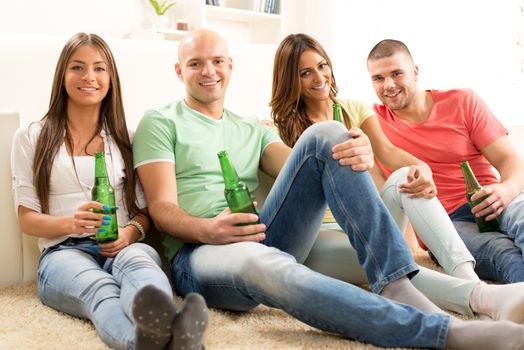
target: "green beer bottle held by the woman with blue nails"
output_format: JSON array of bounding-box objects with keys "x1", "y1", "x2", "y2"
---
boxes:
[{"x1": 91, "y1": 152, "x2": 118, "y2": 243}]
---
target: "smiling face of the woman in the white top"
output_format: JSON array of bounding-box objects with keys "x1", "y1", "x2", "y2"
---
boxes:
[{"x1": 64, "y1": 45, "x2": 111, "y2": 107}]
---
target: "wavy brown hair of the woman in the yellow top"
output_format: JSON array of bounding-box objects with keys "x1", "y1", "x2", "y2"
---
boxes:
[{"x1": 269, "y1": 33, "x2": 338, "y2": 147}]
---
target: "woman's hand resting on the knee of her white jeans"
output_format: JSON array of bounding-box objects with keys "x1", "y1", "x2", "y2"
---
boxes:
[{"x1": 399, "y1": 165, "x2": 437, "y2": 199}]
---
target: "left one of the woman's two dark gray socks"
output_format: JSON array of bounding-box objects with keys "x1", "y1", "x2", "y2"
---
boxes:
[{"x1": 133, "y1": 285, "x2": 176, "y2": 350}]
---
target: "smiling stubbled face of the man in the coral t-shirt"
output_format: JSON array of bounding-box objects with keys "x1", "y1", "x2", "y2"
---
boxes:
[{"x1": 368, "y1": 51, "x2": 418, "y2": 111}]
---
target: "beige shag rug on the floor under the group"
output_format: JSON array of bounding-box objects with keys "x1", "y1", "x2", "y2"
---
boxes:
[{"x1": 0, "y1": 250, "x2": 448, "y2": 350}]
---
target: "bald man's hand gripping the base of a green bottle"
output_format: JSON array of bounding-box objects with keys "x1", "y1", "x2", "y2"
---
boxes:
[{"x1": 202, "y1": 208, "x2": 266, "y2": 244}]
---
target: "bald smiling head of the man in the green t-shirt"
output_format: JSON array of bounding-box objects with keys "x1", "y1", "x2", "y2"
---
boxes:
[{"x1": 175, "y1": 30, "x2": 233, "y2": 110}]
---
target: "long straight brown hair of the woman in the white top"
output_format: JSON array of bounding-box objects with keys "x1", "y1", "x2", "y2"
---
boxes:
[{"x1": 33, "y1": 33, "x2": 138, "y2": 213}]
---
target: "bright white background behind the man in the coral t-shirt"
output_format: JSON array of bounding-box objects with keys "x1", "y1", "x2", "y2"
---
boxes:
[{"x1": 329, "y1": 0, "x2": 524, "y2": 124}]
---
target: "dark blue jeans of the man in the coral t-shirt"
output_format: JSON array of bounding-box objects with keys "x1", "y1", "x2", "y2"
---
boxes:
[{"x1": 450, "y1": 193, "x2": 524, "y2": 283}]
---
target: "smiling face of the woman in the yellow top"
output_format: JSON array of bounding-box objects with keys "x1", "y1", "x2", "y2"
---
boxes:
[{"x1": 298, "y1": 50, "x2": 332, "y2": 103}]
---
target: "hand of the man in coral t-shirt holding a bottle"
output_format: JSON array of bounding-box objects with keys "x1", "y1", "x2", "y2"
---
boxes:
[{"x1": 471, "y1": 183, "x2": 518, "y2": 221}]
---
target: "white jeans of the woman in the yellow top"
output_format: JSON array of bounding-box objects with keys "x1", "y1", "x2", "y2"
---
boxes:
[{"x1": 305, "y1": 168, "x2": 478, "y2": 316}]
